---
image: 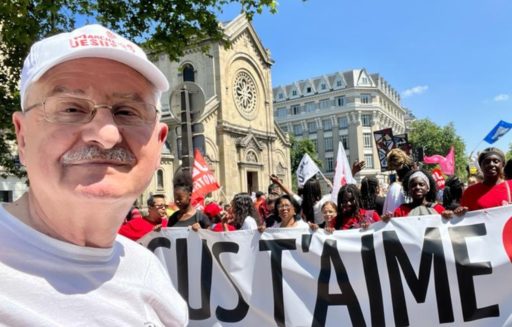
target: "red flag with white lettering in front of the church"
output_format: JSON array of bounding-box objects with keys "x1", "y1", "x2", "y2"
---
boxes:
[{"x1": 191, "y1": 149, "x2": 220, "y2": 208}]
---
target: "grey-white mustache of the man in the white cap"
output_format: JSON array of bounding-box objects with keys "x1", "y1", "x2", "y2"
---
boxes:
[{"x1": 62, "y1": 146, "x2": 135, "y2": 164}]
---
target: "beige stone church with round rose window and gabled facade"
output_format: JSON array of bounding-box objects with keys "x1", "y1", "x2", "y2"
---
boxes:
[{"x1": 139, "y1": 15, "x2": 291, "y2": 205}]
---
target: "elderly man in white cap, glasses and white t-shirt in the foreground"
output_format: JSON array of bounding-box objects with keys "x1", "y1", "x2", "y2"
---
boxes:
[{"x1": 0, "y1": 25, "x2": 188, "y2": 326}]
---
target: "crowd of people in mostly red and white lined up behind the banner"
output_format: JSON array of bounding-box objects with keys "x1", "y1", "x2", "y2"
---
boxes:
[{"x1": 119, "y1": 148, "x2": 511, "y2": 239}]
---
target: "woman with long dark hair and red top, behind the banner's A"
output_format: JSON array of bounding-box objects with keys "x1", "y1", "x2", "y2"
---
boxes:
[{"x1": 335, "y1": 184, "x2": 380, "y2": 229}]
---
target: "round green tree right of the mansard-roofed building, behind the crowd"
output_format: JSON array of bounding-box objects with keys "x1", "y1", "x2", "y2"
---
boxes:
[{"x1": 409, "y1": 119, "x2": 467, "y2": 177}]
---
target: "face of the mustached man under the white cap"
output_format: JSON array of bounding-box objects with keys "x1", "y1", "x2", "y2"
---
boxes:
[{"x1": 13, "y1": 58, "x2": 167, "y2": 201}]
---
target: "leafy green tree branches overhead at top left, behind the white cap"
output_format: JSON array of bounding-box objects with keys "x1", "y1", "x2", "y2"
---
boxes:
[{"x1": 0, "y1": 0, "x2": 277, "y2": 177}]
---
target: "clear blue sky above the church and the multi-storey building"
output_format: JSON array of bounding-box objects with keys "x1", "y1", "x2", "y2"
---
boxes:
[{"x1": 220, "y1": 0, "x2": 512, "y2": 154}]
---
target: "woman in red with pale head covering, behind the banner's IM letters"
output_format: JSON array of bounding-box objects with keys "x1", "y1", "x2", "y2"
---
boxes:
[{"x1": 393, "y1": 169, "x2": 444, "y2": 217}]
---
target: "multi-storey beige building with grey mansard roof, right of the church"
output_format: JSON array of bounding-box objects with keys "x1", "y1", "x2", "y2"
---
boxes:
[{"x1": 273, "y1": 69, "x2": 406, "y2": 186}]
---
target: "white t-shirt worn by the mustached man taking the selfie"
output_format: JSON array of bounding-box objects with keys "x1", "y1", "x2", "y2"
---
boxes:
[{"x1": 0, "y1": 206, "x2": 188, "y2": 326}]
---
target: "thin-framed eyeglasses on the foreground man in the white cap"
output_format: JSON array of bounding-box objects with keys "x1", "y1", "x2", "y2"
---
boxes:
[{"x1": 24, "y1": 97, "x2": 158, "y2": 126}]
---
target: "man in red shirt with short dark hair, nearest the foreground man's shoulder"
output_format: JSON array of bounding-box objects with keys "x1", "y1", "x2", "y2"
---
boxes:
[{"x1": 119, "y1": 194, "x2": 167, "y2": 241}]
